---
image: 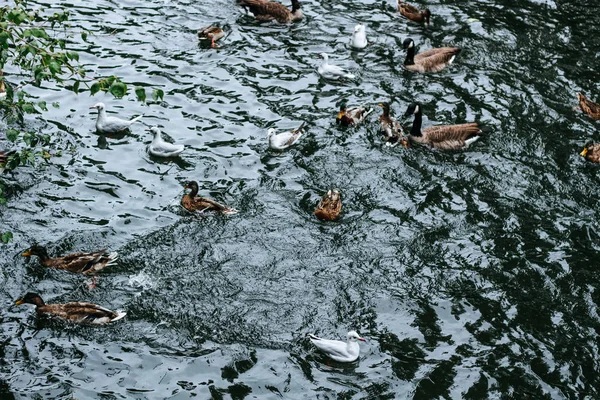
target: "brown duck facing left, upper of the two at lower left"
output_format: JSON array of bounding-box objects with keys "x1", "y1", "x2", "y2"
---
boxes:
[{"x1": 21, "y1": 245, "x2": 119, "y2": 275}]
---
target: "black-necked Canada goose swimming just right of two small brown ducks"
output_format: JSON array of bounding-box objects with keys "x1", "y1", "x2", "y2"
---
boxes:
[{"x1": 404, "y1": 103, "x2": 483, "y2": 150}]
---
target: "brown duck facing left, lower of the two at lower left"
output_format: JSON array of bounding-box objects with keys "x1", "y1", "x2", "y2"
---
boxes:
[{"x1": 15, "y1": 293, "x2": 127, "y2": 325}]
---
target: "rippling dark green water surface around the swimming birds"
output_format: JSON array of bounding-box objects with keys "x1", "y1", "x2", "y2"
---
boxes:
[{"x1": 0, "y1": 0, "x2": 600, "y2": 399}]
